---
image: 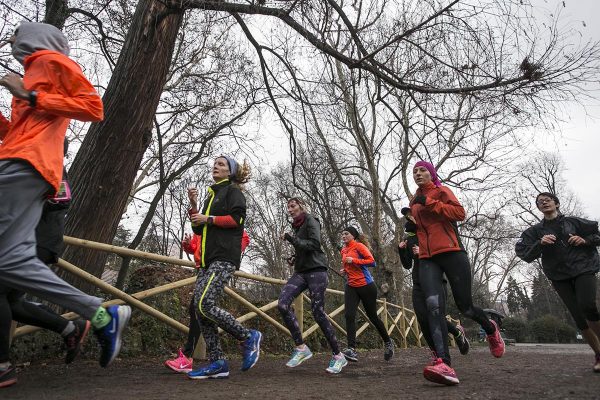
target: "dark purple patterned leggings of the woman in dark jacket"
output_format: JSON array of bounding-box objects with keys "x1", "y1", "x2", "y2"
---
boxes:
[{"x1": 277, "y1": 271, "x2": 340, "y2": 354}]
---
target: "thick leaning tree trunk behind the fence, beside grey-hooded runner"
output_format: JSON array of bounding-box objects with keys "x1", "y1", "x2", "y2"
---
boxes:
[{"x1": 64, "y1": 0, "x2": 183, "y2": 290}]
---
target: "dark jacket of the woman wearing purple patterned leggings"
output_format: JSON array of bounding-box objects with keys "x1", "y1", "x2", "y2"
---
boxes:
[{"x1": 288, "y1": 214, "x2": 327, "y2": 272}]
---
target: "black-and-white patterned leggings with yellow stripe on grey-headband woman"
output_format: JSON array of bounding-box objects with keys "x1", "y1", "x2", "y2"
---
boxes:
[{"x1": 194, "y1": 261, "x2": 250, "y2": 361}]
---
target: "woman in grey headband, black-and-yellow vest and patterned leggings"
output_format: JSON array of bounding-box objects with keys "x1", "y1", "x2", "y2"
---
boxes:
[{"x1": 187, "y1": 156, "x2": 262, "y2": 379}]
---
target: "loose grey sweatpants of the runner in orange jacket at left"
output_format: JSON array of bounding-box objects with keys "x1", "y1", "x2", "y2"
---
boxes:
[{"x1": 0, "y1": 160, "x2": 102, "y2": 319}]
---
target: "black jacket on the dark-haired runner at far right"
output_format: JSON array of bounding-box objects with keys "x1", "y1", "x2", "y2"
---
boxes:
[{"x1": 515, "y1": 215, "x2": 600, "y2": 281}]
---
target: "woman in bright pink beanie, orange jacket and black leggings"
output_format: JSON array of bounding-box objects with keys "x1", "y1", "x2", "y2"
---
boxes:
[{"x1": 410, "y1": 161, "x2": 504, "y2": 385}]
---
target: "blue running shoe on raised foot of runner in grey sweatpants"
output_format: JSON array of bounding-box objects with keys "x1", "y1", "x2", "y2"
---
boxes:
[{"x1": 94, "y1": 306, "x2": 131, "y2": 368}]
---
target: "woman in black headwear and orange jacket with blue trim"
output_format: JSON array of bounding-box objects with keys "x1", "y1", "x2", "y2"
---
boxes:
[{"x1": 340, "y1": 226, "x2": 394, "y2": 361}]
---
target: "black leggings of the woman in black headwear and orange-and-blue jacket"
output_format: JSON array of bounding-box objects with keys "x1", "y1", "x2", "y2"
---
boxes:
[{"x1": 344, "y1": 282, "x2": 390, "y2": 348}]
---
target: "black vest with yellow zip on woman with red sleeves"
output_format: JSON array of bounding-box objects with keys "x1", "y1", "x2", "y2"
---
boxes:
[{"x1": 192, "y1": 179, "x2": 246, "y2": 269}]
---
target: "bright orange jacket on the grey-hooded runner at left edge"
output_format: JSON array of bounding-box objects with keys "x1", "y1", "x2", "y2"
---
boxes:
[{"x1": 0, "y1": 50, "x2": 104, "y2": 191}]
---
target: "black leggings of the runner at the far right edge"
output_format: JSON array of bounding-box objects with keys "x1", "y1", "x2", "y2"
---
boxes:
[{"x1": 551, "y1": 273, "x2": 600, "y2": 330}]
